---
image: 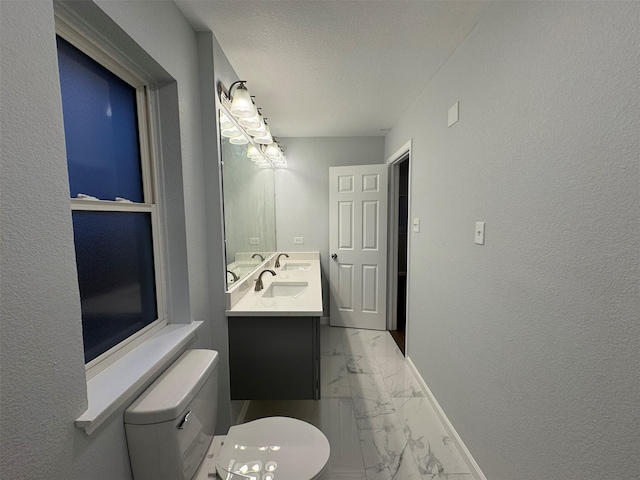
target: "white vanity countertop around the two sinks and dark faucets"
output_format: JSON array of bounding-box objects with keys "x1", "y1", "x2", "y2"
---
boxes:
[{"x1": 226, "y1": 252, "x2": 322, "y2": 317}]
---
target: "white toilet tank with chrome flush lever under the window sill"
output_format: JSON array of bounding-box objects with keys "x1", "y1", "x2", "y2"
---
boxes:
[{"x1": 124, "y1": 350, "x2": 218, "y2": 480}]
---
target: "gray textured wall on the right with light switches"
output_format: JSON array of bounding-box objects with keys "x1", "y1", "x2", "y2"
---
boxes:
[{"x1": 385, "y1": 2, "x2": 640, "y2": 480}]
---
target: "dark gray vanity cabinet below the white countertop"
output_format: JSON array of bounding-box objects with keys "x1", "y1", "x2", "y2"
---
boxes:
[{"x1": 228, "y1": 316, "x2": 320, "y2": 400}]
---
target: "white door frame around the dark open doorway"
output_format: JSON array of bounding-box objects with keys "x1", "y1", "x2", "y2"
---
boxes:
[{"x1": 387, "y1": 139, "x2": 413, "y2": 344}]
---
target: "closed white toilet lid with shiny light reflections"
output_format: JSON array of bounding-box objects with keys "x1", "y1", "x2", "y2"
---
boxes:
[{"x1": 216, "y1": 417, "x2": 330, "y2": 480}]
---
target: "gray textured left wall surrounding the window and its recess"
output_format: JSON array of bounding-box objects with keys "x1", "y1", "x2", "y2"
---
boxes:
[{"x1": 0, "y1": 1, "x2": 230, "y2": 480}]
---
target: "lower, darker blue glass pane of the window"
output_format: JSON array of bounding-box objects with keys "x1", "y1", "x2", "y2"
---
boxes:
[{"x1": 73, "y1": 210, "x2": 158, "y2": 362}]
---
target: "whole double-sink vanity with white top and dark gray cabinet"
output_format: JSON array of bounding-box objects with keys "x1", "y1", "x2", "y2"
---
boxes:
[{"x1": 226, "y1": 252, "x2": 322, "y2": 400}]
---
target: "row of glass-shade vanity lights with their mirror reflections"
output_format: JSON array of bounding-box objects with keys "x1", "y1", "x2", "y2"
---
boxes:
[{"x1": 218, "y1": 80, "x2": 287, "y2": 168}]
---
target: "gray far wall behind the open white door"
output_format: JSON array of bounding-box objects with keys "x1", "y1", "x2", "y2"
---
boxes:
[{"x1": 276, "y1": 137, "x2": 385, "y2": 316}]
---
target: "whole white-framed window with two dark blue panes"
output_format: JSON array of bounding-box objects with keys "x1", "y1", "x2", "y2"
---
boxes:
[{"x1": 57, "y1": 24, "x2": 166, "y2": 370}]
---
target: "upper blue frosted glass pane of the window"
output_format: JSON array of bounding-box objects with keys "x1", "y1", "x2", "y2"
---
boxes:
[{"x1": 58, "y1": 37, "x2": 143, "y2": 202}]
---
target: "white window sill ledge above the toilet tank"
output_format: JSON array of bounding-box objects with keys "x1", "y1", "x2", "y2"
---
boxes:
[{"x1": 76, "y1": 322, "x2": 202, "y2": 435}]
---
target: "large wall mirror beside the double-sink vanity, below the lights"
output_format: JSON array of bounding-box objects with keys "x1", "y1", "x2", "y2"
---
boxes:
[{"x1": 220, "y1": 112, "x2": 276, "y2": 288}]
